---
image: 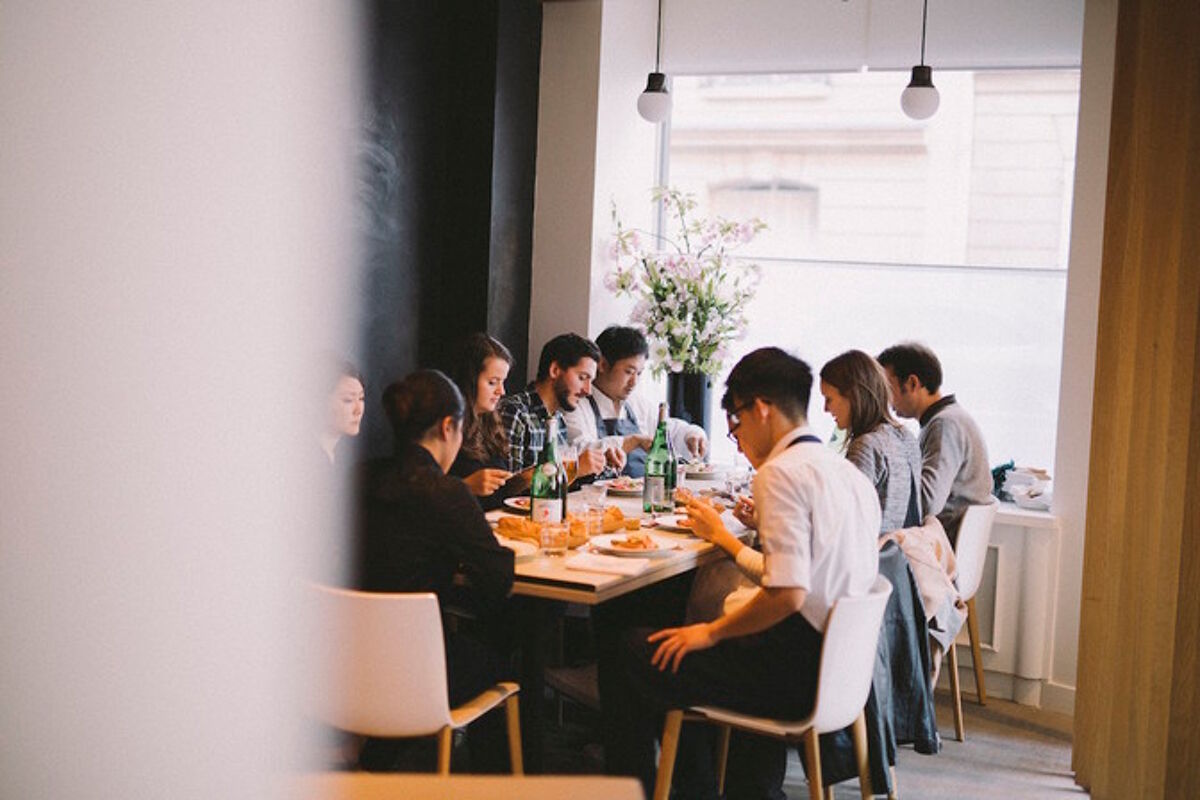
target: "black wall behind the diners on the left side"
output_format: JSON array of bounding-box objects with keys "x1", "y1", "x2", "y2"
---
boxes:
[{"x1": 356, "y1": 0, "x2": 541, "y2": 456}]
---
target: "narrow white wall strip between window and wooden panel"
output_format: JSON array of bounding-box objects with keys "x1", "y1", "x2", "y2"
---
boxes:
[{"x1": 1042, "y1": 0, "x2": 1117, "y2": 712}]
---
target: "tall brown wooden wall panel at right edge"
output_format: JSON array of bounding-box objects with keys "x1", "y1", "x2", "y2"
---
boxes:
[{"x1": 1074, "y1": 0, "x2": 1200, "y2": 799}]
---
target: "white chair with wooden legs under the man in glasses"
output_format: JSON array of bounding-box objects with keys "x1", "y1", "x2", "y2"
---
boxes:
[{"x1": 654, "y1": 576, "x2": 892, "y2": 800}]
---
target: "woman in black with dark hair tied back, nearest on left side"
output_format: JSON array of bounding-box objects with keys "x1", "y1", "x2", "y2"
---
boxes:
[{"x1": 359, "y1": 369, "x2": 512, "y2": 772}]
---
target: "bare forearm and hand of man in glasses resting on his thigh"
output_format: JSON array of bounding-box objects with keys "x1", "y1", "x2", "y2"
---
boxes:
[{"x1": 647, "y1": 587, "x2": 808, "y2": 672}]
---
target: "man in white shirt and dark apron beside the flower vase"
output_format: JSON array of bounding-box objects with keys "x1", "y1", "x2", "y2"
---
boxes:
[{"x1": 564, "y1": 325, "x2": 708, "y2": 477}]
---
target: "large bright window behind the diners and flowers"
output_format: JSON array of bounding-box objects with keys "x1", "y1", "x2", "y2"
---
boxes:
[{"x1": 667, "y1": 70, "x2": 1079, "y2": 468}]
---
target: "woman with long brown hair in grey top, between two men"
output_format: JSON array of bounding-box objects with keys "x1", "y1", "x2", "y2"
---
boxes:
[{"x1": 821, "y1": 350, "x2": 922, "y2": 535}]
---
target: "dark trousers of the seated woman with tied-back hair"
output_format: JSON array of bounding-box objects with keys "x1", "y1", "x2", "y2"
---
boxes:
[{"x1": 359, "y1": 632, "x2": 509, "y2": 772}]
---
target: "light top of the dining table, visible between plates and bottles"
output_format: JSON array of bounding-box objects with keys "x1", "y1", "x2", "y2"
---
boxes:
[{"x1": 488, "y1": 481, "x2": 745, "y2": 606}]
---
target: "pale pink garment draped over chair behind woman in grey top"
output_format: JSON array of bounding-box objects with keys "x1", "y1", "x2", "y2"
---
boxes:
[{"x1": 880, "y1": 516, "x2": 967, "y2": 651}]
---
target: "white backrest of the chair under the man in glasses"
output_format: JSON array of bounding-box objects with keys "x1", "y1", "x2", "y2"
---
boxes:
[{"x1": 812, "y1": 575, "x2": 892, "y2": 733}]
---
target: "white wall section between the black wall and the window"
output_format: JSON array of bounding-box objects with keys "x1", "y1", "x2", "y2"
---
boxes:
[{"x1": 529, "y1": 0, "x2": 658, "y2": 372}]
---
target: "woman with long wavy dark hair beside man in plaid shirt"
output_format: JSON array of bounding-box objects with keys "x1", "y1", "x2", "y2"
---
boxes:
[{"x1": 450, "y1": 333, "x2": 526, "y2": 511}]
